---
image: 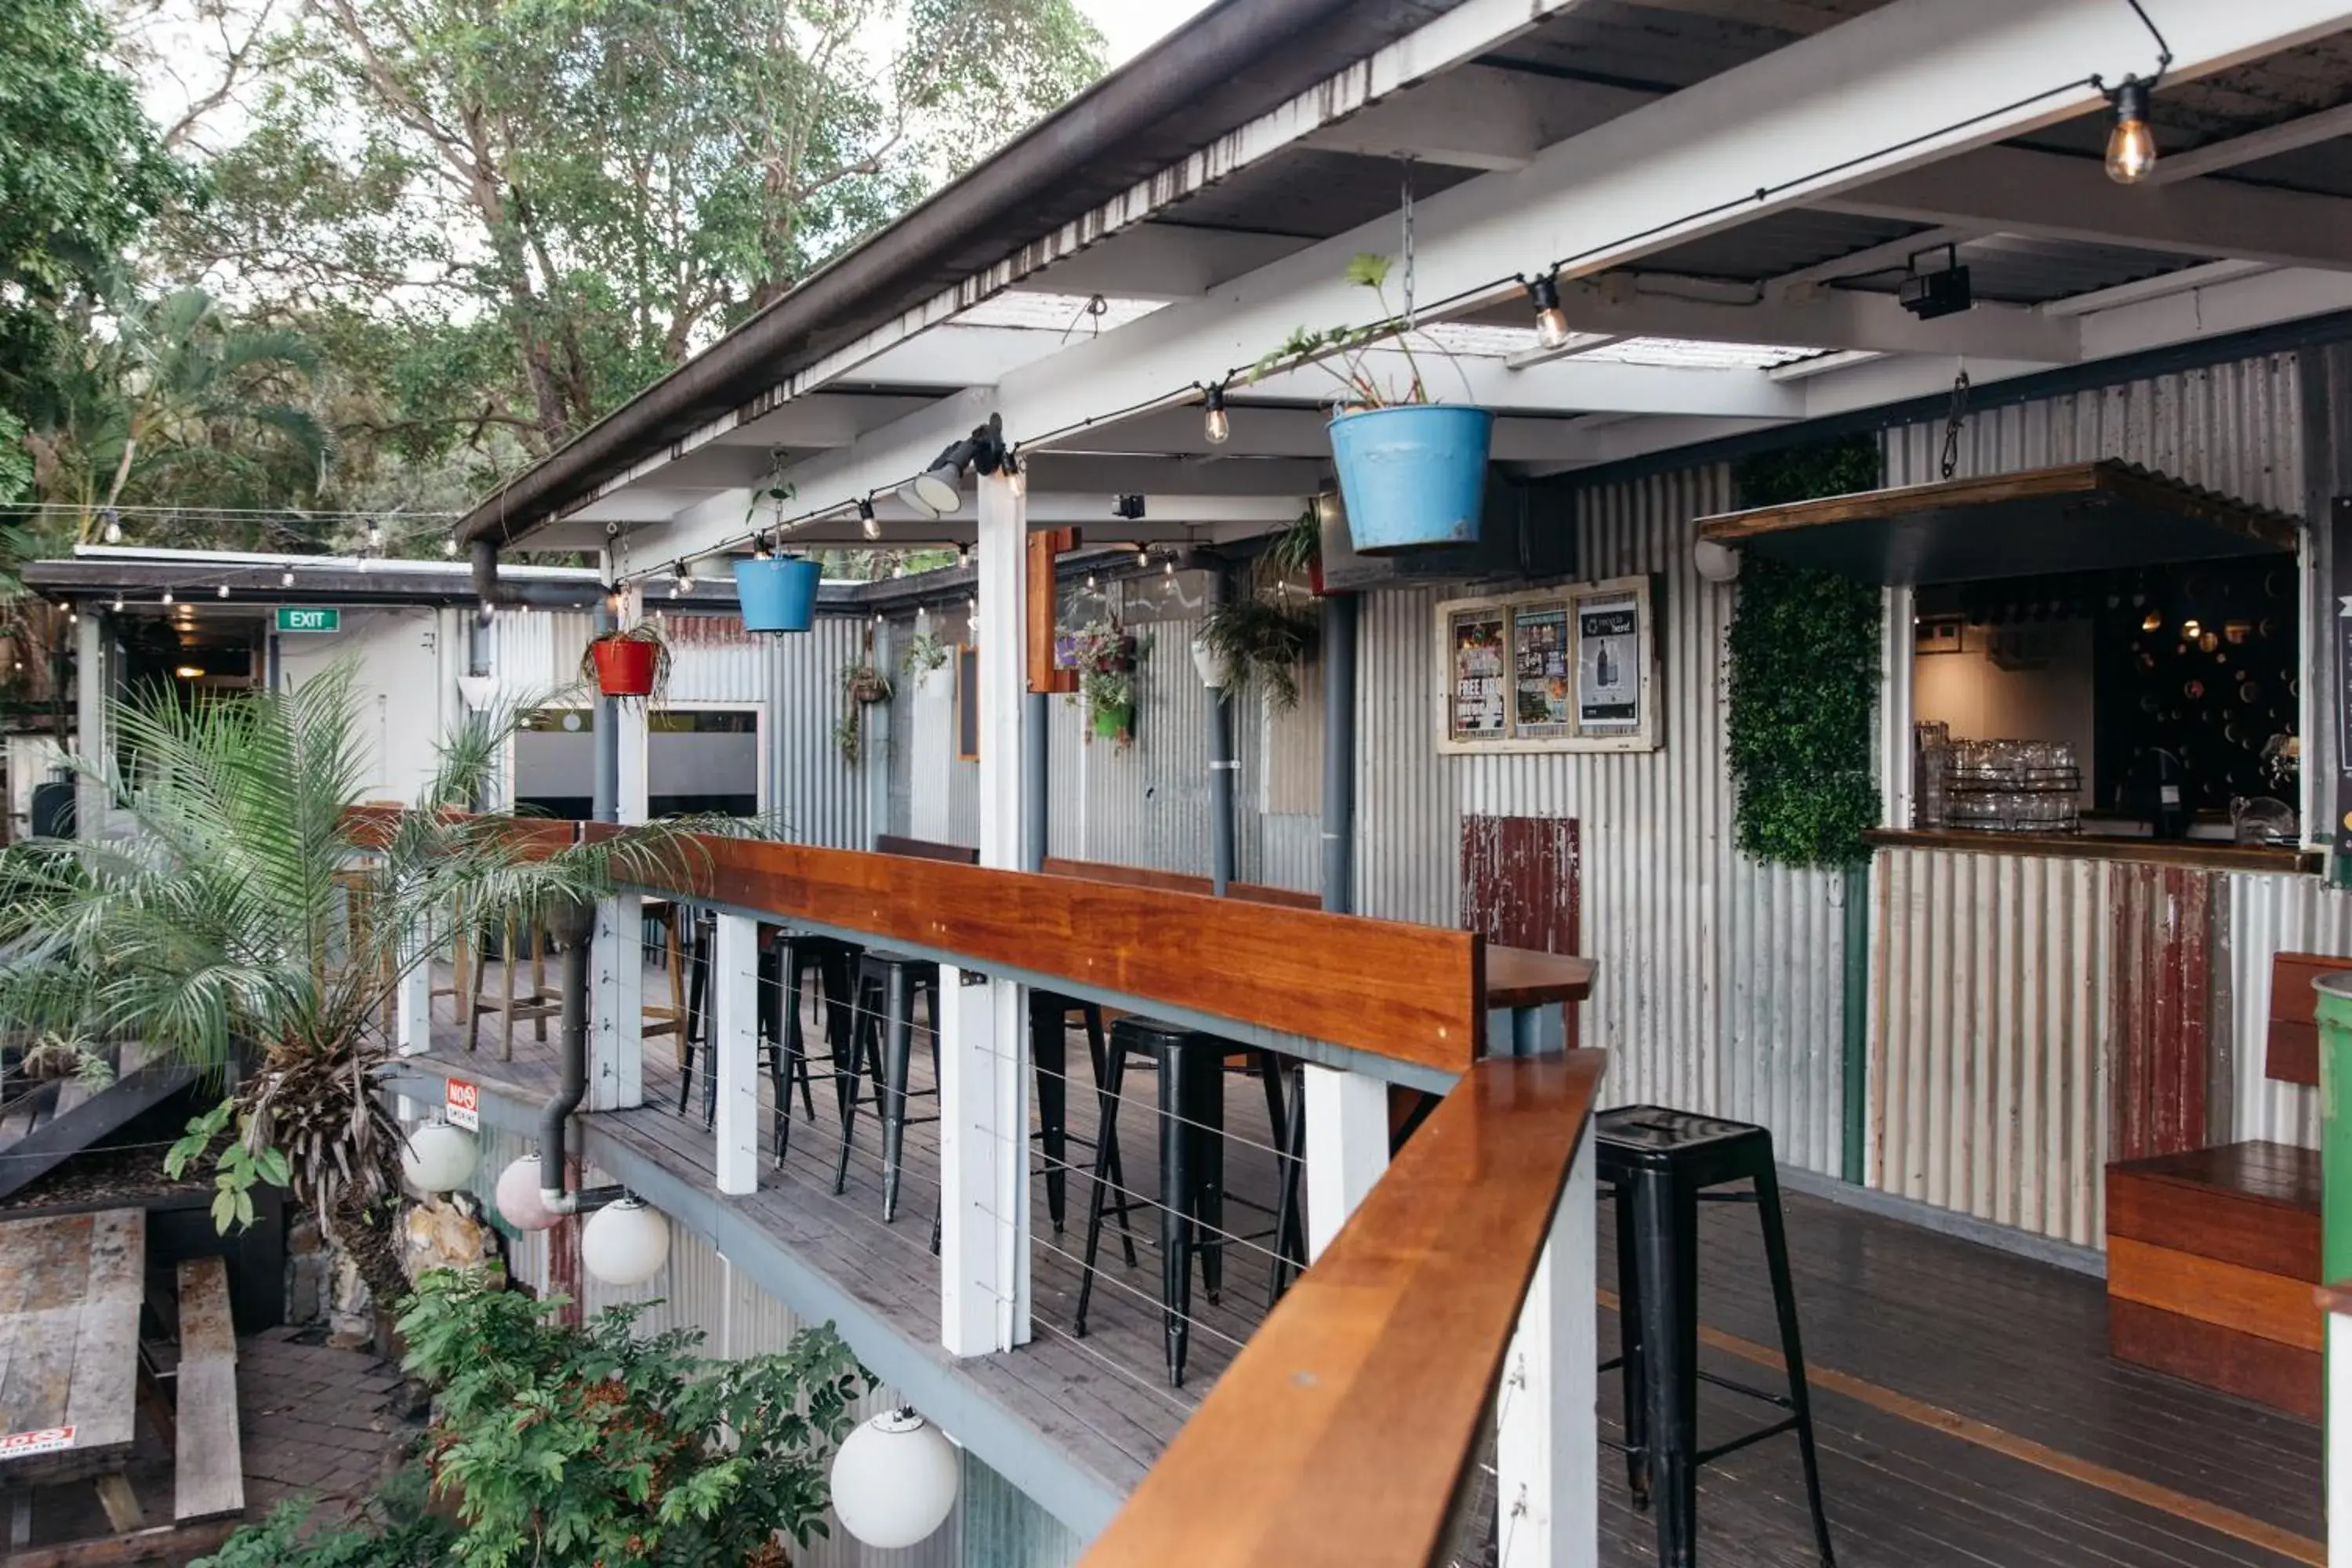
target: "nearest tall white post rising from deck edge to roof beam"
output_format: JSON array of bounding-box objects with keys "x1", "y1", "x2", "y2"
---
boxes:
[{"x1": 938, "y1": 475, "x2": 1030, "y2": 1356}]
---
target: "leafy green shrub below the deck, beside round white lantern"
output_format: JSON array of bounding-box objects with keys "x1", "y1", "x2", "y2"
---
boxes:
[{"x1": 200, "y1": 1269, "x2": 873, "y2": 1568}]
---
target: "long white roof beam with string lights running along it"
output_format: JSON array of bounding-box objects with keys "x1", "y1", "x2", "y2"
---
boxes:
[{"x1": 621, "y1": 0, "x2": 2352, "y2": 569}]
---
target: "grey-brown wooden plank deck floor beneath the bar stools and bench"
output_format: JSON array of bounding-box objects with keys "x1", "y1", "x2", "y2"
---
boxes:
[{"x1": 405, "y1": 959, "x2": 2326, "y2": 1568}]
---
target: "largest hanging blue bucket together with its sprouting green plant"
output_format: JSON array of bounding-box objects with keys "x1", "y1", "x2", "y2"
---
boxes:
[{"x1": 1251, "y1": 256, "x2": 1494, "y2": 555}]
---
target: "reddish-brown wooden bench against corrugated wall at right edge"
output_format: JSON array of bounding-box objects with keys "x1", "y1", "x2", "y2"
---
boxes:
[{"x1": 2107, "y1": 952, "x2": 2352, "y2": 1420}]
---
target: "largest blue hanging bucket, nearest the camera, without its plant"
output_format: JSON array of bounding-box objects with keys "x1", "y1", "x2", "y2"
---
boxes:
[{"x1": 1331, "y1": 402, "x2": 1494, "y2": 555}]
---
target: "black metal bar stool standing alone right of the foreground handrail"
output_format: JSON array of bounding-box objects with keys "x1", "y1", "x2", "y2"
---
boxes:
[{"x1": 1592, "y1": 1105, "x2": 1837, "y2": 1568}]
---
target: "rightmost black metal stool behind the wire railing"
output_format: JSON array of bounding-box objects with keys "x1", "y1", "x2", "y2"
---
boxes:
[{"x1": 1075, "y1": 1018, "x2": 1305, "y2": 1387}]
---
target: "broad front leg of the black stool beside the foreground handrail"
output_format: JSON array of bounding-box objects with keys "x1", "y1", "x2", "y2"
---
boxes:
[{"x1": 1635, "y1": 1175, "x2": 1698, "y2": 1568}]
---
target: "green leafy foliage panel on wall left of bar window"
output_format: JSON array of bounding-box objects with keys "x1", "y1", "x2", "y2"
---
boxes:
[{"x1": 1726, "y1": 437, "x2": 1884, "y2": 865}]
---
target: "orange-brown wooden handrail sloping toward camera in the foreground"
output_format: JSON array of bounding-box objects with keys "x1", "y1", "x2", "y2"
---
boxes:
[{"x1": 1082, "y1": 1051, "x2": 1604, "y2": 1568}]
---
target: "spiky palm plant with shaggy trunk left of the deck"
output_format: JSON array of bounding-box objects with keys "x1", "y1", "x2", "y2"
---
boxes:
[{"x1": 0, "y1": 666, "x2": 691, "y2": 1309}]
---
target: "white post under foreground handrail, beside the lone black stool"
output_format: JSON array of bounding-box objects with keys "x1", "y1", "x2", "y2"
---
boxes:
[{"x1": 1494, "y1": 1131, "x2": 1599, "y2": 1568}]
